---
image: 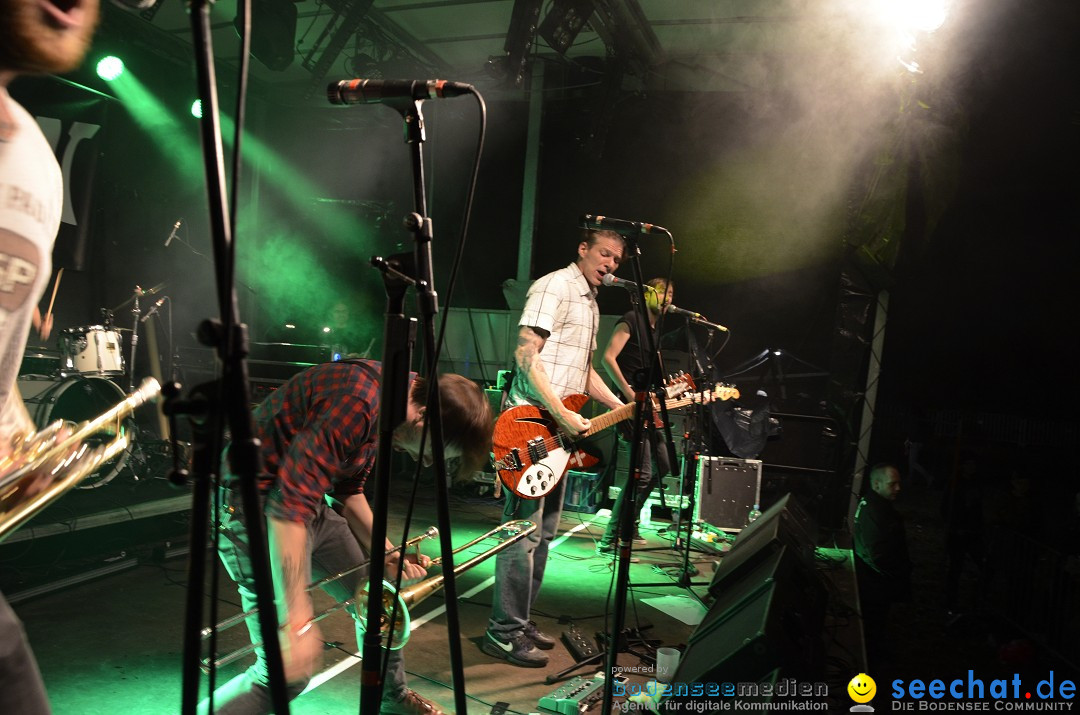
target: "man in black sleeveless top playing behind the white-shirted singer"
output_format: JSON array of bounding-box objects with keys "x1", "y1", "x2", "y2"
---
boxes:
[{"x1": 596, "y1": 278, "x2": 675, "y2": 555}]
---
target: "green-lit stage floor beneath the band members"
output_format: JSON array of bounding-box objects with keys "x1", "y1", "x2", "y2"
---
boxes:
[{"x1": 5, "y1": 480, "x2": 858, "y2": 715}]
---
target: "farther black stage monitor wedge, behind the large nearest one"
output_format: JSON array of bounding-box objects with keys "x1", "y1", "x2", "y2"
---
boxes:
[{"x1": 708, "y1": 494, "x2": 816, "y2": 596}]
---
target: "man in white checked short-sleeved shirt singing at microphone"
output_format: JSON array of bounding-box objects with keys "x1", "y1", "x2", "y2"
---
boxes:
[{"x1": 481, "y1": 229, "x2": 625, "y2": 667}]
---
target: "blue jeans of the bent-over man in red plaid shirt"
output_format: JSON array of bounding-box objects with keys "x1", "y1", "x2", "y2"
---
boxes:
[{"x1": 199, "y1": 490, "x2": 408, "y2": 715}]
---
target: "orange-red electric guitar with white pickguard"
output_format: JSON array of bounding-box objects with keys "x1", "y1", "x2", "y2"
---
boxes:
[{"x1": 492, "y1": 376, "x2": 739, "y2": 499}]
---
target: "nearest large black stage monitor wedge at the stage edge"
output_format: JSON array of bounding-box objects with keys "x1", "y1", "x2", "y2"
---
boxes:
[{"x1": 674, "y1": 537, "x2": 827, "y2": 683}]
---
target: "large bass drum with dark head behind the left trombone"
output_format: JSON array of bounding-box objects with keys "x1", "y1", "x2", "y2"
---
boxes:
[{"x1": 17, "y1": 375, "x2": 135, "y2": 489}]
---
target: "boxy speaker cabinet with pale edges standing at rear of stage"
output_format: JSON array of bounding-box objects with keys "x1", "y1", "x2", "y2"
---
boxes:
[{"x1": 693, "y1": 457, "x2": 761, "y2": 531}]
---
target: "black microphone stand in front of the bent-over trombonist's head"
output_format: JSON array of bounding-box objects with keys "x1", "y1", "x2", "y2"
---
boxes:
[{"x1": 360, "y1": 98, "x2": 469, "y2": 715}]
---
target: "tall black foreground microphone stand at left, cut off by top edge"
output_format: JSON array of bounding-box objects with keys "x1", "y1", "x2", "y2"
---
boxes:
[{"x1": 164, "y1": 0, "x2": 288, "y2": 715}]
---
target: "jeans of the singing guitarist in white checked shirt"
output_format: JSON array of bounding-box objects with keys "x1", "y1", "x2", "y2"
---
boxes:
[{"x1": 487, "y1": 475, "x2": 566, "y2": 638}]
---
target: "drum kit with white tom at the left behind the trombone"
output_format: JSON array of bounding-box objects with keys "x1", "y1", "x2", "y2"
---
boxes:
[{"x1": 17, "y1": 284, "x2": 164, "y2": 489}]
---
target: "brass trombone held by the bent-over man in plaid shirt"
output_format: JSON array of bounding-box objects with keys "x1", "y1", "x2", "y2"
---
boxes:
[{"x1": 201, "y1": 521, "x2": 537, "y2": 672}]
